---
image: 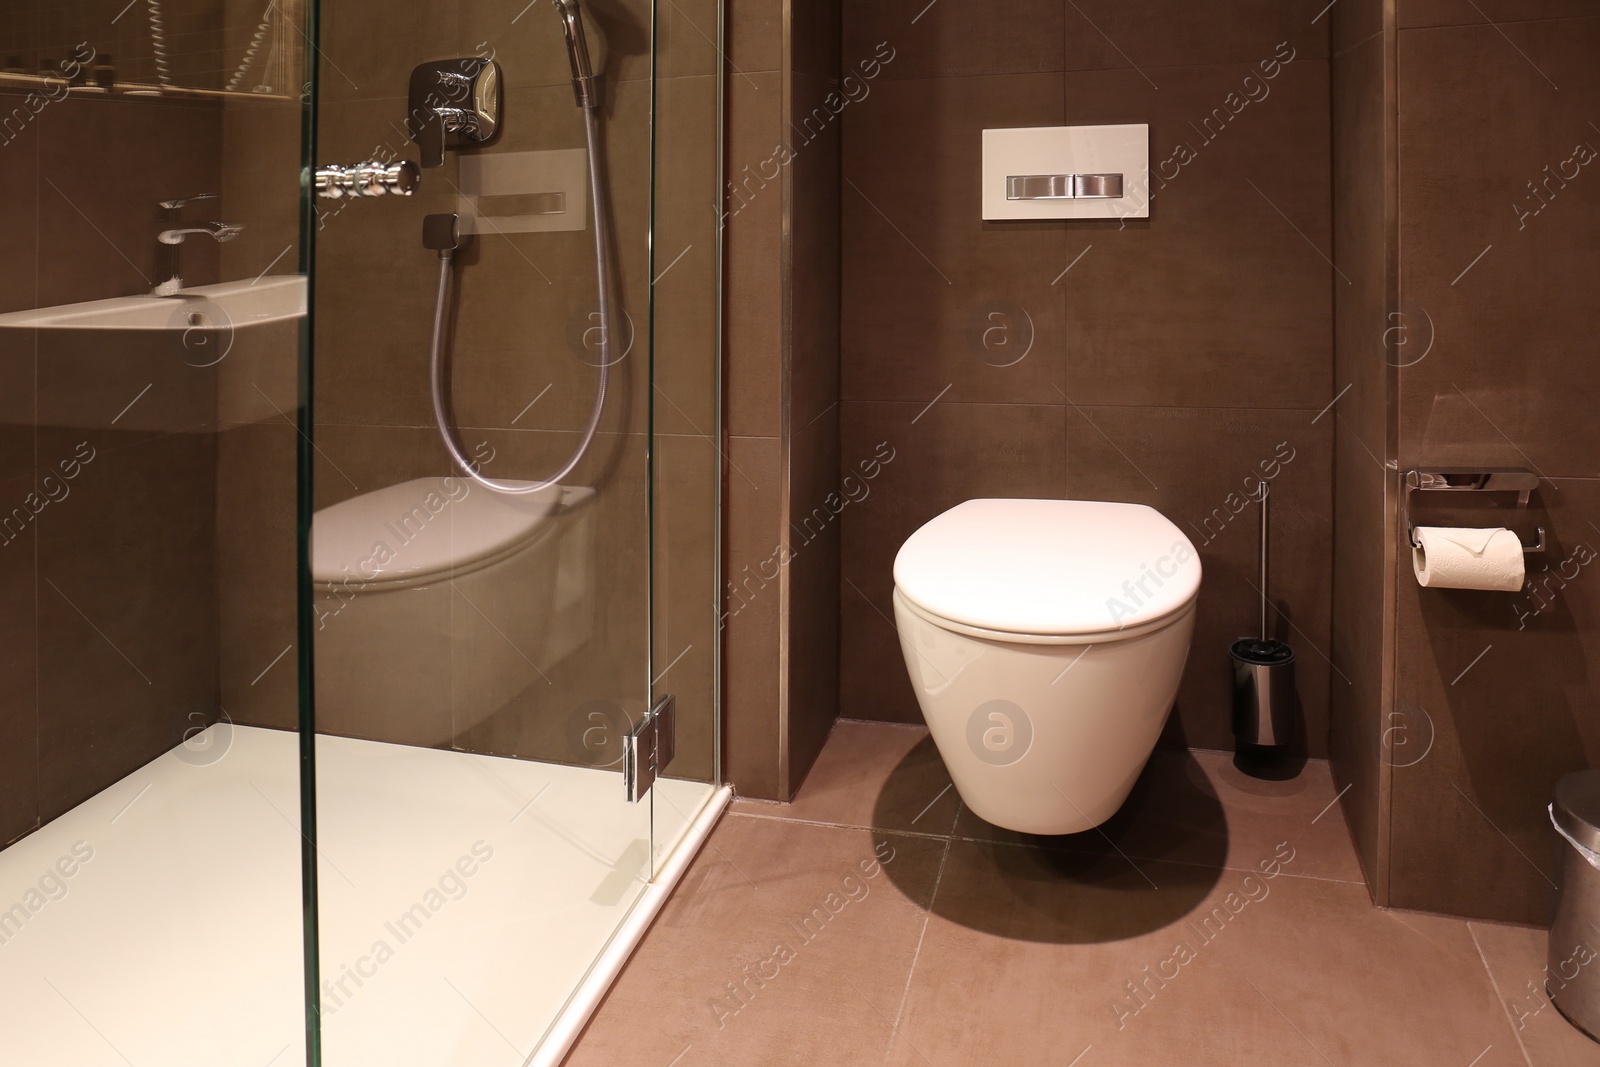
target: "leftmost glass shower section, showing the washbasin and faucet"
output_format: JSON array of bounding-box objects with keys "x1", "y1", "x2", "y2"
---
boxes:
[{"x1": 0, "y1": 0, "x2": 306, "y2": 1067}]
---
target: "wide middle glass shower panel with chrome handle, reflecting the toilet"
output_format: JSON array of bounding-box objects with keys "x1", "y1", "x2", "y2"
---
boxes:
[{"x1": 307, "y1": 0, "x2": 668, "y2": 1067}]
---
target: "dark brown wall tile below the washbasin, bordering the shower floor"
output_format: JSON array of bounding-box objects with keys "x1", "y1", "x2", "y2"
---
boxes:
[{"x1": 37, "y1": 429, "x2": 218, "y2": 821}]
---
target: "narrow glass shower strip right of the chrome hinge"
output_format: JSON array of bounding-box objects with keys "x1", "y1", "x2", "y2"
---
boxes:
[{"x1": 650, "y1": 0, "x2": 723, "y2": 872}]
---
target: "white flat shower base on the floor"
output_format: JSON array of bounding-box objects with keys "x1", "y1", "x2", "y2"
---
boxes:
[{"x1": 0, "y1": 725, "x2": 728, "y2": 1067}]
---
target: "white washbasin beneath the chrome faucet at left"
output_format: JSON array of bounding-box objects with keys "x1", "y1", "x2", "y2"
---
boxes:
[{"x1": 0, "y1": 275, "x2": 306, "y2": 330}]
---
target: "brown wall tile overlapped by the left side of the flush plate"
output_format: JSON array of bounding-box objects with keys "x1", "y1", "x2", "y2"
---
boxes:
[{"x1": 840, "y1": 74, "x2": 1082, "y2": 403}]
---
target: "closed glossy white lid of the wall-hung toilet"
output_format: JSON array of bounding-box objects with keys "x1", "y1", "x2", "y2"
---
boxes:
[{"x1": 894, "y1": 499, "x2": 1200, "y2": 635}]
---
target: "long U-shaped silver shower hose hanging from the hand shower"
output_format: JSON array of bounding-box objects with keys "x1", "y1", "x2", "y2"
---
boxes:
[{"x1": 429, "y1": 97, "x2": 616, "y2": 494}]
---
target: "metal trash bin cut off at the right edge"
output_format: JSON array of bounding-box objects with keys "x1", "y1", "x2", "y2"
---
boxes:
[{"x1": 1544, "y1": 771, "x2": 1600, "y2": 1041}]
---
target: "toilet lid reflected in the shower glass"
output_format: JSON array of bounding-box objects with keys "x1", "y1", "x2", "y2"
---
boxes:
[{"x1": 310, "y1": 477, "x2": 562, "y2": 582}]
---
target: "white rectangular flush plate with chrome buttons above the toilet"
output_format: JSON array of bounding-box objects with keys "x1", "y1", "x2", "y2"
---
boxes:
[{"x1": 984, "y1": 123, "x2": 1150, "y2": 219}]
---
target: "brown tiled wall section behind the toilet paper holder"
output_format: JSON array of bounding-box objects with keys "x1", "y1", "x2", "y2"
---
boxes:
[{"x1": 1389, "y1": 18, "x2": 1600, "y2": 923}]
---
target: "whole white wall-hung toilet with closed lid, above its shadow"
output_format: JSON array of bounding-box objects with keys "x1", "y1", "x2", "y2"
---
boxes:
[{"x1": 894, "y1": 499, "x2": 1200, "y2": 833}]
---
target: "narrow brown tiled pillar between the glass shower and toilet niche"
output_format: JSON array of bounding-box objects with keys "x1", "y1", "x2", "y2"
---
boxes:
[{"x1": 723, "y1": 2, "x2": 844, "y2": 800}]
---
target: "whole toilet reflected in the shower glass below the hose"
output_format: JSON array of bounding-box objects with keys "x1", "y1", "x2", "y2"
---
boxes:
[{"x1": 310, "y1": 478, "x2": 595, "y2": 747}]
